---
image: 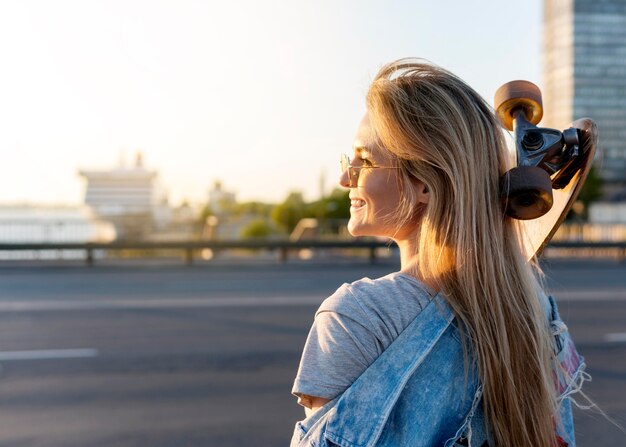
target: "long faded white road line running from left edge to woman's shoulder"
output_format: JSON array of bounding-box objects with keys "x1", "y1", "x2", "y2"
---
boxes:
[{"x1": 0, "y1": 296, "x2": 326, "y2": 312}]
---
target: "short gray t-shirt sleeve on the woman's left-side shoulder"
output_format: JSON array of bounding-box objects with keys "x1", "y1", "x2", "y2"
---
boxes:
[{"x1": 292, "y1": 284, "x2": 384, "y2": 399}]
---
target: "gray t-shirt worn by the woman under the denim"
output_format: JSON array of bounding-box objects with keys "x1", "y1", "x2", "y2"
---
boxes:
[{"x1": 292, "y1": 272, "x2": 434, "y2": 403}]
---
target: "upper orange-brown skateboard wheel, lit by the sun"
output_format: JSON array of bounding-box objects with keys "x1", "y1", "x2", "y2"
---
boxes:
[{"x1": 494, "y1": 81, "x2": 543, "y2": 130}]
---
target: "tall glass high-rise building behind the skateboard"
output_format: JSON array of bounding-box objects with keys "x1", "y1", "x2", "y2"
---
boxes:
[{"x1": 542, "y1": 0, "x2": 626, "y2": 198}]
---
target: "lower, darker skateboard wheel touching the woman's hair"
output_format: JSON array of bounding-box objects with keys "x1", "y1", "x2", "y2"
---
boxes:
[{"x1": 500, "y1": 166, "x2": 553, "y2": 220}]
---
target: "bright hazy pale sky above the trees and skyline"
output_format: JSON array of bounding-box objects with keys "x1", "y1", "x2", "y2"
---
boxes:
[{"x1": 0, "y1": 0, "x2": 542, "y2": 205}]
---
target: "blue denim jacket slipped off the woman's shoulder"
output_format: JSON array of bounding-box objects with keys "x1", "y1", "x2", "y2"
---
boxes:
[{"x1": 291, "y1": 295, "x2": 585, "y2": 447}]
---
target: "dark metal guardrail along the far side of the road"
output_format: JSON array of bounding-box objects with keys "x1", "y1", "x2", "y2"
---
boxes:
[{"x1": 0, "y1": 239, "x2": 626, "y2": 265}]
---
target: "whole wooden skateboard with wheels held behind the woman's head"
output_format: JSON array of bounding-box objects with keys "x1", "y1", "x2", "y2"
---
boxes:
[{"x1": 494, "y1": 81, "x2": 598, "y2": 259}]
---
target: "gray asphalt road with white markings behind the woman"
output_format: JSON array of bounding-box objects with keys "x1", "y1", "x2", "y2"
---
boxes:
[{"x1": 0, "y1": 260, "x2": 626, "y2": 447}]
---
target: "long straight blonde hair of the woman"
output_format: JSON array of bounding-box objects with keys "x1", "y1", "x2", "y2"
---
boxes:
[{"x1": 367, "y1": 59, "x2": 558, "y2": 447}]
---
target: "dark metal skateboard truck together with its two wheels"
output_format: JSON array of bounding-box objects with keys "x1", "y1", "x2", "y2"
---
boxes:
[{"x1": 495, "y1": 81, "x2": 586, "y2": 220}]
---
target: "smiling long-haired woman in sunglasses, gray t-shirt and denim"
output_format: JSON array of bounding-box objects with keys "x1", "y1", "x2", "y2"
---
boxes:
[{"x1": 292, "y1": 60, "x2": 584, "y2": 447}]
